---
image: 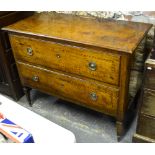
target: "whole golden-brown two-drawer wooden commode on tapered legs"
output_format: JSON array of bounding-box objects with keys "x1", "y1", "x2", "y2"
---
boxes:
[{"x1": 3, "y1": 12, "x2": 152, "y2": 140}]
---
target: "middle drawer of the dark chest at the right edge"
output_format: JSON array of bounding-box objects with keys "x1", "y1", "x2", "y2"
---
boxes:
[{"x1": 141, "y1": 89, "x2": 155, "y2": 117}]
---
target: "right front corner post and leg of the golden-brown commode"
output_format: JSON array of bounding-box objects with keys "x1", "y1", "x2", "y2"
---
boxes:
[{"x1": 116, "y1": 55, "x2": 131, "y2": 139}]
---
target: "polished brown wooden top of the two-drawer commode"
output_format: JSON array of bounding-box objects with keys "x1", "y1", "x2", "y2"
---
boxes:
[{"x1": 3, "y1": 12, "x2": 152, "y2": 54}]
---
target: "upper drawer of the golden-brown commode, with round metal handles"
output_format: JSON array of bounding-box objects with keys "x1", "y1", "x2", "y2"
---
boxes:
[{"x1": 10, "y1": 35, "x2": 120, "y2": 85}]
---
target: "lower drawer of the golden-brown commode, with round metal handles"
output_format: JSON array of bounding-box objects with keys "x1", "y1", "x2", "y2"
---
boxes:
[{"x1": 18, "y1": 63, "x2": 119, "y2": 115}]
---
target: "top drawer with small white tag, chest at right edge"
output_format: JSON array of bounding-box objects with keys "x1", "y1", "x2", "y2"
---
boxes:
[{"x1": 145, "y1": 64, "x2": 155, "y2": 90}]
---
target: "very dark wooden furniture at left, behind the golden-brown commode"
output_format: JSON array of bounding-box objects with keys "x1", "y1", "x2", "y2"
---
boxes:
[{"x1": 0, "y1": 11, "x2": 33, "y2": 100}]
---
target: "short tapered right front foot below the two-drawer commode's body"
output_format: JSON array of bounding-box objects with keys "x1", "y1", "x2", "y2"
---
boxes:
[{"x1": 116, "y1": 121, "x2": 124, "y2": 141}]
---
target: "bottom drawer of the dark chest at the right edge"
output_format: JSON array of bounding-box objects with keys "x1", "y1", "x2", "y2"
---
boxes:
[{"x1": 137, "y1": 115, "x2": 155, "y2": 139}]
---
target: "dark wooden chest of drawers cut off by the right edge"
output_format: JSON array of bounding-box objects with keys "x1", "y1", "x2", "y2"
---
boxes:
[{"x1": 133, "y1": 42, "x2": 155, "y2": 143}]
